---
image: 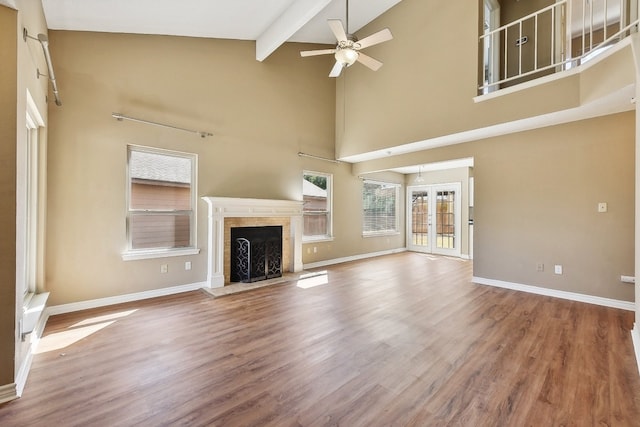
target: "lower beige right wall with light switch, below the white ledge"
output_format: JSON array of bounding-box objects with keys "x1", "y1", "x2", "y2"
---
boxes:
[{"x1": 354, "y1": 112, "x2": 635, "y2": 301}]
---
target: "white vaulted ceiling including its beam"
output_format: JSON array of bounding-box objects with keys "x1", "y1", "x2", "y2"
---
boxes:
[{"x1": 42, "y1": 0, "x2": 401, "y2": 61}]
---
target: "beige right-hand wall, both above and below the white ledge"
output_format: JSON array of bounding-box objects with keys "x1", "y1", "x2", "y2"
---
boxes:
[{"x1": 336, "y1": 0, "x2": 635, "y2": 301}]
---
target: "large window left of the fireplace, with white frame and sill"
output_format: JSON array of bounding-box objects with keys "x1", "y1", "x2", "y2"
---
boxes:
[{"x1": 123, "y1": 146, "x2": 198, "y2": 259}]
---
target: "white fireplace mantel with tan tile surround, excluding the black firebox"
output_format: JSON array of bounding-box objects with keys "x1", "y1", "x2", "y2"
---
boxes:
[{"x1": 202, "y1": 197, "x2": 302, "y2": 288}]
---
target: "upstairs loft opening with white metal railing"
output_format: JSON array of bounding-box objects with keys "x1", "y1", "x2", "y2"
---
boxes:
[{"x1": 478, "y1": 0, "x2": 639, "y2": 94}]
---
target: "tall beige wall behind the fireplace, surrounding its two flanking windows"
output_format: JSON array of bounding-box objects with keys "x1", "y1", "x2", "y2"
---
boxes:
[{"x1": 47, "y1": 31, "x2": 404, "y2": 305}]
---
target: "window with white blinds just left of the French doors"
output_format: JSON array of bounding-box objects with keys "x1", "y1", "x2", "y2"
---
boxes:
[{"x1": 362, "y1": 180, "x2": 400, "y2": 235}]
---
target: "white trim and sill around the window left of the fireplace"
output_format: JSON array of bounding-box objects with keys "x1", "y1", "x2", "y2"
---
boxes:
[{"x1": 121, "y1": 144, "x2": 200, "y2": 261}]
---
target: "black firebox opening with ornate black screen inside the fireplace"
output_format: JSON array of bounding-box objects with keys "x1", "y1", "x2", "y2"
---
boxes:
[{"x1": 231, "y1": 226, "x2": 282, "y2": 283}]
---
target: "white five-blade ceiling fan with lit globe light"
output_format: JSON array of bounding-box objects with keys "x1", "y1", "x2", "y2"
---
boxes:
[{"x1": 300, "y1": 0, "x2": 393, "y2": 77}]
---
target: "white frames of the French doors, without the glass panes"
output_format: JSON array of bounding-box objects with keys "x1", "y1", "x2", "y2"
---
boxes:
[{"x1": 406, "y1": 182, "x2": 462, "y2": 257}]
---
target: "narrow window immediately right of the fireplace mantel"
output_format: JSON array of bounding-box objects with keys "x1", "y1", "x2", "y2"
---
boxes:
[{"x1": 302, "y1": 171, "x2": 332, "y2": 240}]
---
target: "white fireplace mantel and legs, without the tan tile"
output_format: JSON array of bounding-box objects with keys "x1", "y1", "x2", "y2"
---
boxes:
[{"x1": 202, "y1": 197, "x2": 303, "y2": 288}]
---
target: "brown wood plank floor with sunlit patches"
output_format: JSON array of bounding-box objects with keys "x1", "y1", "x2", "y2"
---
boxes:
[{"x1": 0, "y1": 253, "x2": 640, "y2": 426}]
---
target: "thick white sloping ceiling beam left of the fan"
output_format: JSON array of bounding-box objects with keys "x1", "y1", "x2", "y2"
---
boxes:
[{"x1": 256, "y1": 0, "x2": 331, "y2": 62}]
